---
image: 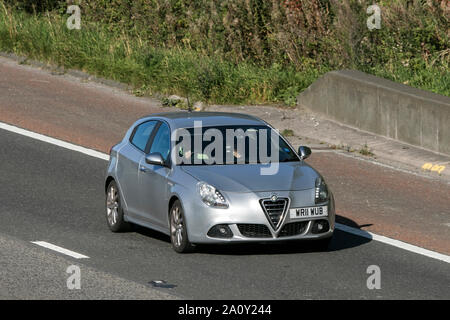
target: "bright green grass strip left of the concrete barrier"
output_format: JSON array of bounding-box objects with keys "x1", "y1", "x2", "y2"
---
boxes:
[{"x1": 0, "y1": 3, "x2": 329, "y2": 105}]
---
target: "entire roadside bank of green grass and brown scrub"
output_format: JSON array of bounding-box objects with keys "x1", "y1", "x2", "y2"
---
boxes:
[{"x1": 0, "y1": 0, "x2": 450, "y2": 105}]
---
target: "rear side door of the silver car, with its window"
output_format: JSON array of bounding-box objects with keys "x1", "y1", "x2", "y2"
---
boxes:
[{"x1": 117, "y1": 120, "x2": 158, "y2": 218}]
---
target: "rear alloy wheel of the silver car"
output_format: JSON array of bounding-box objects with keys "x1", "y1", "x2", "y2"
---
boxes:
[{"x1": 106, "y1": 180, "x2": 130, "y2": 232}]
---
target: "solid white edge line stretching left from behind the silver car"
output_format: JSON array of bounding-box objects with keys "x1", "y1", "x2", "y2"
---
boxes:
[{"x1": 0, "y1": 122, "x2": 109, "y2": 161}]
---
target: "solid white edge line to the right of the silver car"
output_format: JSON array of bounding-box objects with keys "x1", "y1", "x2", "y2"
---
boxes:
[{"x1": 335, "y1": 223, "x2": 450, "y2": 263}]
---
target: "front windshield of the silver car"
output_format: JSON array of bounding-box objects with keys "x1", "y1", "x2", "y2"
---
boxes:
[{"x1": 173, "y1": 125, "x2": 300, "y2": 165}]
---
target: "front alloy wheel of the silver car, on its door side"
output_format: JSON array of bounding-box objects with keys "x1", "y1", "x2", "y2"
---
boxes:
[{"x1": 169, "y1": 200, "x2": 194, "y2": 253}]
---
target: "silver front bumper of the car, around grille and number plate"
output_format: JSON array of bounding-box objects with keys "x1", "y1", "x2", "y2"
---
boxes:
[{"x1": 184, "y1": 190, "x2": 335, "y2": 244}]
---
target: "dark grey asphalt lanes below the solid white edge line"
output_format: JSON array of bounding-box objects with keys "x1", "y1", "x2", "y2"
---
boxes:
[{"x1": 0, "y1": 130, "x2": 450, "y2": 299}]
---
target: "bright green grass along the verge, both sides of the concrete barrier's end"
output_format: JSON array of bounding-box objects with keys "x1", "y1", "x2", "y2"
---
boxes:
[{"x1": 0, "y1": 0, "x2": 450, "y2": 105}]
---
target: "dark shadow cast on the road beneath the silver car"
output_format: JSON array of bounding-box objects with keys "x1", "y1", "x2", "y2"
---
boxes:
[{"x1": 129, "y1": 215, "x2": 372, "y2": 255}]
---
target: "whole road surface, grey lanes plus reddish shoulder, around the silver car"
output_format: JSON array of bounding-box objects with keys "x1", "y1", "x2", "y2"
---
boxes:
[{"x1": 0, "y1": 56, "x2": 450, "y2": 299}]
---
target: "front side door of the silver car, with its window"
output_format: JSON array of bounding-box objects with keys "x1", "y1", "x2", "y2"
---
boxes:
[{"x1": 139, "y1": 122, "x2": 170, "y2": 228}]
